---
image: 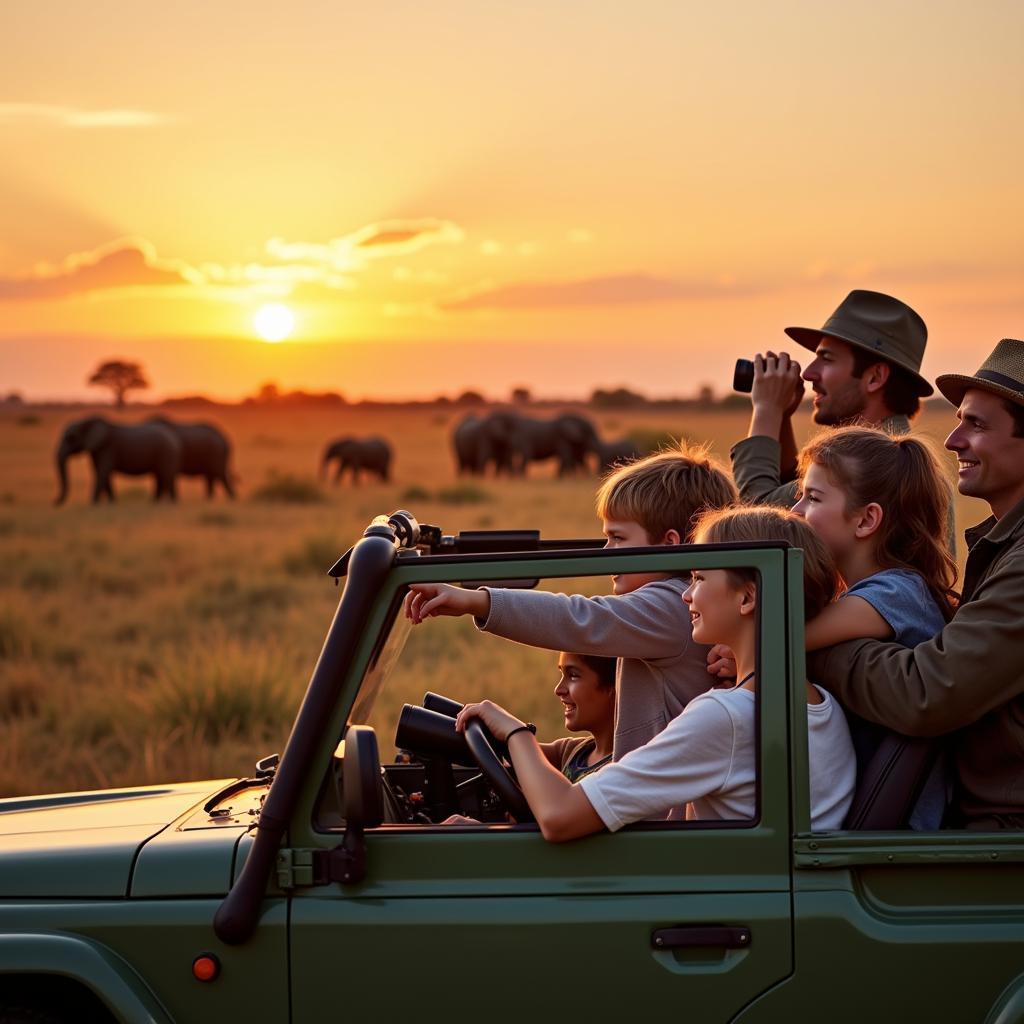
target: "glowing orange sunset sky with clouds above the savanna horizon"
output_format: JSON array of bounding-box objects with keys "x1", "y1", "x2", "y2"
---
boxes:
[{"x1": 0, "y1": 0, "x2": 1024, "y2": 399}]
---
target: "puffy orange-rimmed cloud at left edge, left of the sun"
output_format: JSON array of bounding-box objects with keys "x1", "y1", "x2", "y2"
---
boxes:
[{"x1": 0, "y1": 239, "x2": 202, "y2": 301}]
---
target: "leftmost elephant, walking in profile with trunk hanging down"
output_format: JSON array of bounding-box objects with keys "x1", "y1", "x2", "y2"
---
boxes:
[{"x1": 56, "y1": 416, "x2": 181, "y2": 505}]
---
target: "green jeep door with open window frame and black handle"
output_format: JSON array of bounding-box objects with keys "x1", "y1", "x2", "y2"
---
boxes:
[{"x1": 290, "y1": 548, "x2": 803, "y2": 1024}]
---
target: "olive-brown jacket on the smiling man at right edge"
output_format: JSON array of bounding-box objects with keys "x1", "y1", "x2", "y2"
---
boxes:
[{"x1": 808, "y1": 493, "x2": 1024, "y2": 823}]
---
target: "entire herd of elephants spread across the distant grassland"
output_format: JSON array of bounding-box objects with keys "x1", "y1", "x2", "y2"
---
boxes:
[{"x1": 56, "y1": 410, "x2": 641, "y2": 505}]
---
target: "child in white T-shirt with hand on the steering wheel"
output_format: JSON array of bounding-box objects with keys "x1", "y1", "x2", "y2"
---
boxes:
[{"x1": 457, "y1": 506, "x2": 856, "y2": 842}]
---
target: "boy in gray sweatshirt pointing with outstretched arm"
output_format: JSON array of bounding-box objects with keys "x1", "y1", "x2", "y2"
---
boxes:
[{"x1": 406, "y1": 445, "x2": 736, "y2": 761}]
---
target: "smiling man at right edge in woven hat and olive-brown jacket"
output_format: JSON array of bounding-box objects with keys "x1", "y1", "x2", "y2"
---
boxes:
[{"x1": 810, "y1": 338, "x2": 1024, "y2": 830}]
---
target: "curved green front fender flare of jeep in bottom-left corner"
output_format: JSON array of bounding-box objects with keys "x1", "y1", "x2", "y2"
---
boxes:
[{"x1": 0, "y1": 932, "x2": 172, "y2": 1024}]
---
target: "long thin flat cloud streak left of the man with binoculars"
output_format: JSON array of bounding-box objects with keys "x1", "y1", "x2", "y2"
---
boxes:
[{"x1": 441, "y1": 273, "x2": 737, "y2": 312}]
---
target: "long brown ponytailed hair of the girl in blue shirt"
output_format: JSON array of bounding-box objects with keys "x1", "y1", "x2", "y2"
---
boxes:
[{"x1": 799, "y1": 427, "x2": 957, "y2": 622}]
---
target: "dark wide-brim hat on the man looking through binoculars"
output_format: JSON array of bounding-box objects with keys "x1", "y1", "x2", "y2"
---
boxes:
[{"x1": 785, "y1": 288, "x2": 934, "y2": 398}]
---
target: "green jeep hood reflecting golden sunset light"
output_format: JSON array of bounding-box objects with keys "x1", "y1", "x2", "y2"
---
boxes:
[{"x1": 0, "y1": 779, "x2": 237, "y2": 898}]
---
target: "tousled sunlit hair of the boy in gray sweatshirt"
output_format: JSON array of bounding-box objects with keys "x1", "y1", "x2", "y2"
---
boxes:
[{"x1": 597, "y1": 441, "x2": 738, "y2": 544}]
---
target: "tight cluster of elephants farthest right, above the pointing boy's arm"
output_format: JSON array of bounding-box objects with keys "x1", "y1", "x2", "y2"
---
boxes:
[{"x1": 452, "y1": 410, "x2": 642, "y2": 476}]
